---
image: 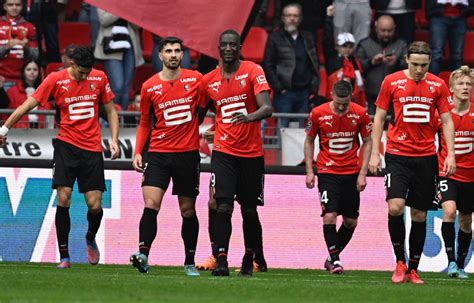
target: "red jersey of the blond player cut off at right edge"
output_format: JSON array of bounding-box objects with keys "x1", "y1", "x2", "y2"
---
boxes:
[{"x1": 438, "y1": 104, "x2": 474, "y2": 182}]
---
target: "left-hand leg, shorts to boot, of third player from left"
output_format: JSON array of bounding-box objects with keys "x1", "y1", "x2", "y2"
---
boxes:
[{"x1": 211, "y1": 151, "x2": 239, "y2": 276}]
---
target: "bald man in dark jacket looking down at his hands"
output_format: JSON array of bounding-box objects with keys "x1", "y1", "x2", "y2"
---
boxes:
[{"x1": 356, "y1": 15, "x2": 406, "y2": 115}]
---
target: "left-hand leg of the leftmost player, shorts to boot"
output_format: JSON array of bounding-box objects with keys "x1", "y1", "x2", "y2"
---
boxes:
[{"x1": 52, "y1": 140, "x2": 80, "y2": 269}]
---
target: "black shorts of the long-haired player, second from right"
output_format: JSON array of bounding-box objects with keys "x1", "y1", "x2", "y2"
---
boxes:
[{"x1": 385, "y1": 153, "x2": 438, "y2": 211}]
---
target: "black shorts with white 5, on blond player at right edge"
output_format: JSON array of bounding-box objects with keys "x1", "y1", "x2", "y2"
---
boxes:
[{"x1": 439, "y1": 178, "x2": 474, "y2": 214}]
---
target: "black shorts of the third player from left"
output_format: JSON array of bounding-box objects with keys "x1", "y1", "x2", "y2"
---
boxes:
[{"x1": 211, "y1": 151, "x2": 265, "y2": 206}]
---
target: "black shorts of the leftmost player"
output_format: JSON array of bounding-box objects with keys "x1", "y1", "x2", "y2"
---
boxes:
[{"x1": 52, "y1": 139, "x2": 106, "y2": 193}]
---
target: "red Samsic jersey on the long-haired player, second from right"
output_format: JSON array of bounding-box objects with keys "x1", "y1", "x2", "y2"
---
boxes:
[{"x1": 375, "y1": 71, "x2": 452, "y2": 157}]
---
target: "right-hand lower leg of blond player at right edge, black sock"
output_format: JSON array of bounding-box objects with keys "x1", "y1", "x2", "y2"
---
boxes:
[{"x1": 457, "y1": 211, "x2": 472, "y2": 279}]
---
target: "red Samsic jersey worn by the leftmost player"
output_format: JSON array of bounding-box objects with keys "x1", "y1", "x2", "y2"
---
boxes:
[{"x1": 32, "y1": 69, "x2": 115, "y2": 152}]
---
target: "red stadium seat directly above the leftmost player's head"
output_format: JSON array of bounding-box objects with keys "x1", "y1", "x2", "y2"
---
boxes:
[{"x1": 58, "y1": 22, "x2": 91, "y2": 54}]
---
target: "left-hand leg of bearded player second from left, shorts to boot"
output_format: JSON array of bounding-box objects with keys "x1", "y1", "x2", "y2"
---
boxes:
[{"x1": 130, "y1": 153, "x2": 170, "y2": 273}]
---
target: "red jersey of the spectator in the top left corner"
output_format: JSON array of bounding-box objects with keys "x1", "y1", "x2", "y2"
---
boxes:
[{"x1": 0, "y1": 16, "x2": 38, "y2": 79}]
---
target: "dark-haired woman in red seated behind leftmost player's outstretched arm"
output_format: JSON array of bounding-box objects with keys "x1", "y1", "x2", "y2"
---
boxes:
[{"x1": 2, "y1": 60, "x2": 53, "y2": 128}]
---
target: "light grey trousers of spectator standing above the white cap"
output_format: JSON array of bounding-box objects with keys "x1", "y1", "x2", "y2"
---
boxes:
[{"x1": 333, "y1": 0, "x2": 372, "y2": 47}]
